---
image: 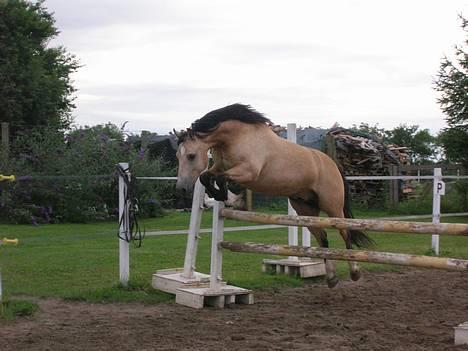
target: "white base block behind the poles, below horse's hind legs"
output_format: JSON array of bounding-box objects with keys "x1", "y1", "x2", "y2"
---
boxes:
[{"x1": 262, "y1": 259, "x2": 326, "y2": 278}]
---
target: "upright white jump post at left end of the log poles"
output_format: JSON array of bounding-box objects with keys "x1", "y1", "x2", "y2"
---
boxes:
[{"x1": 210, "y1": 201, "x2": 224, "y2": 291}]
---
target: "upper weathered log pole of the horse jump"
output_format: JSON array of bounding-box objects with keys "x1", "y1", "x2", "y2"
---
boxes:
[{"x1": 221, "y1": 209, "x2": 468, "y2": 236}]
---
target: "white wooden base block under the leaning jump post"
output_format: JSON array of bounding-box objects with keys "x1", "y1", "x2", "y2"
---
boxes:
[{"x1": 151, "y1": 268, "x2": 210, "y2": 295}]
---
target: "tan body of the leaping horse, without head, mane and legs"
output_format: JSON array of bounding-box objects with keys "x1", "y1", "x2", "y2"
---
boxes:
[{"x1": 219, "y1": 121, "x2": 343, "y2": 205}]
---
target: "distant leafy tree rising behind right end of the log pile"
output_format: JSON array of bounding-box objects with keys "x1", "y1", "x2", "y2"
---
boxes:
[{"x1": 385, "y1": 124, "x2": 436, "y2": 163}]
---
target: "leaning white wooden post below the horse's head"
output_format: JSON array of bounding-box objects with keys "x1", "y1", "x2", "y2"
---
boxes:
[{"x1": 181, "y1": 179, "x2": 205, "y2": 279}]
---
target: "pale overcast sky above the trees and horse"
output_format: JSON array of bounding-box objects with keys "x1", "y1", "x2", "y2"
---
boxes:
[{"x1": 45, "y1": 0, "x2": 468, "y2": 133}]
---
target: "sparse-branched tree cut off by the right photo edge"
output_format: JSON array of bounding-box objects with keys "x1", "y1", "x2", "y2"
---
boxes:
[{"x1": 434, "y1": 16, "x2": 468, "y2": 167}]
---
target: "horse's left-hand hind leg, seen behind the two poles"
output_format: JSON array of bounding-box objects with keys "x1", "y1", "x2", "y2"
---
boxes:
[{"x1": 289, "y1": 198, "x2": 338, "y2": 288}]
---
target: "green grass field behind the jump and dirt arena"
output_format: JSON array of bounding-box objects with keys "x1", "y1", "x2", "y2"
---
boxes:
[{"x1": 0, "y1": 211, "x2": 468, "y2": 303}]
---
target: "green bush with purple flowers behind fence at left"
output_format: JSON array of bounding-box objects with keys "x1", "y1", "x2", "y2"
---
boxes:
[{"x1": 0, "y1": 124, "x2": 174, "y2": 224}]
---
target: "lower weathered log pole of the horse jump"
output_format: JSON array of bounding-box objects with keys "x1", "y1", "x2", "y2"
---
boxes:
[{"x1": 219, "y1": 241, "x2": 468, "y2": 272}]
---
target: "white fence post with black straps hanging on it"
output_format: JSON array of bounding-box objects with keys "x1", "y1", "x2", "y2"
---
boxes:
[{"x1": 119, "y1": 162, "x2": 130, "y2": 286}]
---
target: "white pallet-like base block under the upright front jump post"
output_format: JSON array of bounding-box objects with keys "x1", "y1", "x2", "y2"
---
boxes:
[{"x1": 176, "y1": 285, "x2": 254, "y2": 309}]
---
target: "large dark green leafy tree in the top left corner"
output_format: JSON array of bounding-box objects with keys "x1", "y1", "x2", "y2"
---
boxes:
[{"x1": 0, "y1": 0, "x2": 79, "y2": 130}]
